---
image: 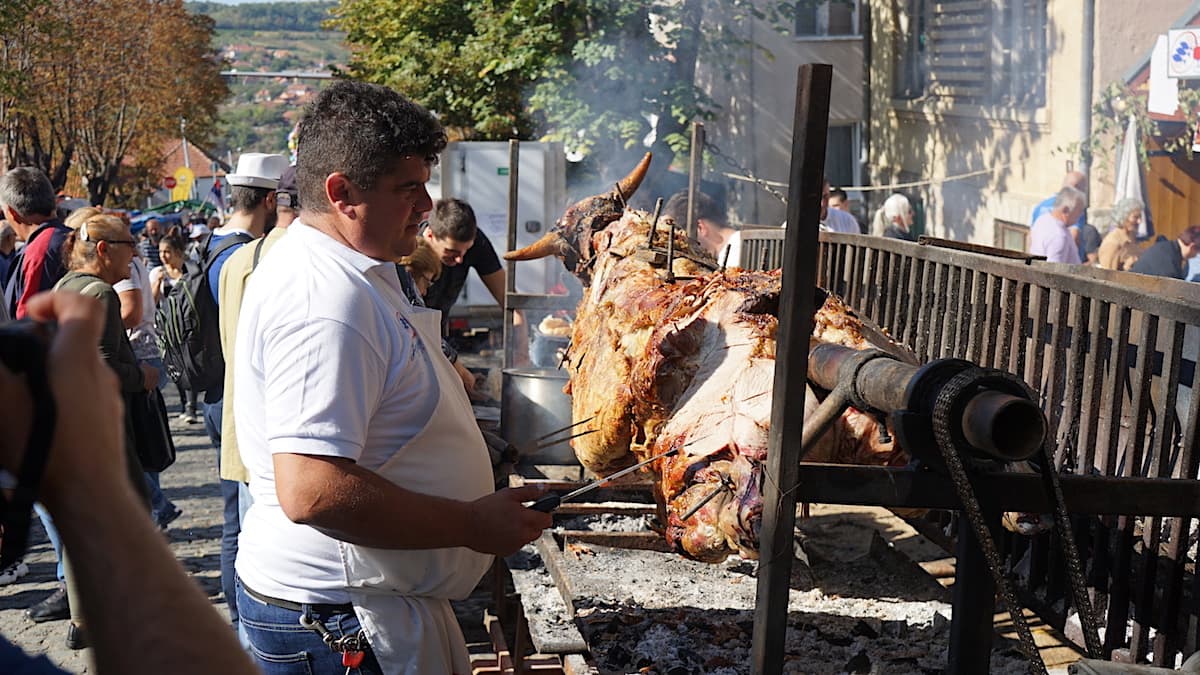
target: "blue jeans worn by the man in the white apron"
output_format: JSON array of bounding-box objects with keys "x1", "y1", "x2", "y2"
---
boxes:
[{"x1": 238, "y1": 580, "x2": 383, "y2": 675}]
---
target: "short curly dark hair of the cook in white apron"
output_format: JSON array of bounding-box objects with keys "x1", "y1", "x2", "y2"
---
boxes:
[{"x1": 296, "y1": 79, "x2": 446, "y2": 211}]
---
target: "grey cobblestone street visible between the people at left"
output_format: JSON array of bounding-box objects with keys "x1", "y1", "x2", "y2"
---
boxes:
[{"x1": 0, "y1": 386, "x2": 226, "y2": 673}]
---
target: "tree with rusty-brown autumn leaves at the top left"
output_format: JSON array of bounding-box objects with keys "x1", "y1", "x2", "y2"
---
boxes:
[{"x1": 0, "y1": 0, "x2": 228, "y2": 204}]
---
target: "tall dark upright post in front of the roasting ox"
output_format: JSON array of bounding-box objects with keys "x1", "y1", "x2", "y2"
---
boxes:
[{"x1": 751, "y1": 64, "x2": 833, "y2": 675}]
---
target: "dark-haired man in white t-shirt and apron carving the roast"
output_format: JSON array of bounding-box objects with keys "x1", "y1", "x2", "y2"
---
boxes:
[{"x1": 234, "y1": 80, "x2": 551, "y2": 674}]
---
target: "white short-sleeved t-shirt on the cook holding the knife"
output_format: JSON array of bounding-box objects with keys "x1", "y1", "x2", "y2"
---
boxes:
[{"x1": 234, "y1": 221, "x2": 440, "y2": 603}]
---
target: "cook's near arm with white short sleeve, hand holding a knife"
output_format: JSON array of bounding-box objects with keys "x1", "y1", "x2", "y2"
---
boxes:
[{"x1": 258, "y1": 312, "x2": 551, "y2": 554}]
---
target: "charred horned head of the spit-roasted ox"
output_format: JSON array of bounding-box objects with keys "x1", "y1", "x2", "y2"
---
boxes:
[{"x1": 504, "y1": 153, "x2": 650, "y2": 277}]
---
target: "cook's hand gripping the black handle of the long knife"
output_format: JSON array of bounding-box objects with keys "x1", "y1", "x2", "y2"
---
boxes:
[{"x1": 469, "y1": 485, "x2": 553, "y2": 556}]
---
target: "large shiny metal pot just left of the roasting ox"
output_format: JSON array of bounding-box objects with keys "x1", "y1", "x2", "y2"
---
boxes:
[{"x1": 500, "y1": 368, "x2": 576, "y2": 464}]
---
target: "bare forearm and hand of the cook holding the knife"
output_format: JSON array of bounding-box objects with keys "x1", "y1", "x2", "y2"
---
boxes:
[{"x1": 272, "y1": 453, "x2": 551, "y2": 555}]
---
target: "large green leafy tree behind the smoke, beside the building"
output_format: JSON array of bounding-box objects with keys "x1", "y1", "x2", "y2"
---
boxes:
[{"x1": 332, "y1": 0, "x2": 792, "y2": 183}]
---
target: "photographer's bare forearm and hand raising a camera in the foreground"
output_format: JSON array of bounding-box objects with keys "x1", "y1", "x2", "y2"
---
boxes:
[{"x1": 0, "y1": 293, "x2": 257, "y2": 675}]
